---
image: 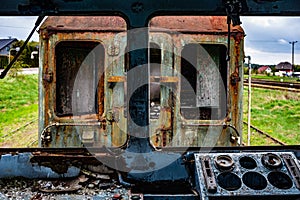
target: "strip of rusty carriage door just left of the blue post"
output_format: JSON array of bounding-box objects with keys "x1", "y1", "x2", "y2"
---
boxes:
[{"x1": 104, "y1": 32, "x2": 128, "y2": 146}]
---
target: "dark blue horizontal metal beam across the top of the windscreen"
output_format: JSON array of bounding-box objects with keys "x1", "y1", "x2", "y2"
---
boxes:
[{"x1": 0, "y1": 0, "x2": 300, "y2": 16}]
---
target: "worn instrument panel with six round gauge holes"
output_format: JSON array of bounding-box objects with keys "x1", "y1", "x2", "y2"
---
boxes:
[{"x1": 195, "y1": 151, "x2": 300, "y2": 199}]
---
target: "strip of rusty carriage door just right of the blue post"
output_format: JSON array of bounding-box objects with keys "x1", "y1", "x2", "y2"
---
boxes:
[{"x1": 149, "y1": 32, "x2": 177, "y2": 147}]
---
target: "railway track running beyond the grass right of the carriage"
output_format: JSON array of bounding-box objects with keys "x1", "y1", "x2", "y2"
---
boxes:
[{"x1": 244, "y1": 79, "x2": 300, "y2": 92}]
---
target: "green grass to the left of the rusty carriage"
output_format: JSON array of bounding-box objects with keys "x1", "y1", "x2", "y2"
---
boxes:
[{"x1": 0, "y1": 75, "x2": 38, "y2": 146}]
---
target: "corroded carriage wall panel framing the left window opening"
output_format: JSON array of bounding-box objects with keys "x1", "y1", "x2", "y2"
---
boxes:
[{"x1": 40, "y1": 26, "x2": 126, "y2": 147}]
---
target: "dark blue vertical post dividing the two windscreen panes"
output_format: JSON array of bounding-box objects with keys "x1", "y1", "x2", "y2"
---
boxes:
[{"x1": 127, "y1": 24, "x2": 153, "y2": 153}]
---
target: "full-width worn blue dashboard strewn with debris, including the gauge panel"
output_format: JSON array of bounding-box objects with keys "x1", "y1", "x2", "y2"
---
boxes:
[{"x1": 0, "y1": 147, "x2": 300, "y2": 200}]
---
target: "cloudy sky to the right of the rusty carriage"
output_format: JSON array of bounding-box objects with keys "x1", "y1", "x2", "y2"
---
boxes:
[{"x1": 241, "y1": 17, "x2": 300, "y2": 64}]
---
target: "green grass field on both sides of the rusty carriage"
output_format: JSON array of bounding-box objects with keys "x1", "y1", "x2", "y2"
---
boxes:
[{"x1": 0, "y1": 75, "x2": 300, "y2": 147}]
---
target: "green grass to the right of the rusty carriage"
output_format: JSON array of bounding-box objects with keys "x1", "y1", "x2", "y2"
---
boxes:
[{"x1": 243, "y1": 87, "x2": 300, "y2": 145}]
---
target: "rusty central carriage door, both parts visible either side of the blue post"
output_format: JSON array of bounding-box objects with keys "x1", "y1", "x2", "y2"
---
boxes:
[{"x1": 105, "y1": 32, "x2": 176, "y2": 147}]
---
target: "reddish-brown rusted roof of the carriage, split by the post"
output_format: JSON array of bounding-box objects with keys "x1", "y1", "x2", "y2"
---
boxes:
[{"x1": 40, "y1": 16, "x2": 243, "y2": 33}]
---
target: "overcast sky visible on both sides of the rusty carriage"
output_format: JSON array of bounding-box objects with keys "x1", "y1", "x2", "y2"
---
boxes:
[{"x1": 0, "y1": 17, "x2": 300, "y2": 65}]
